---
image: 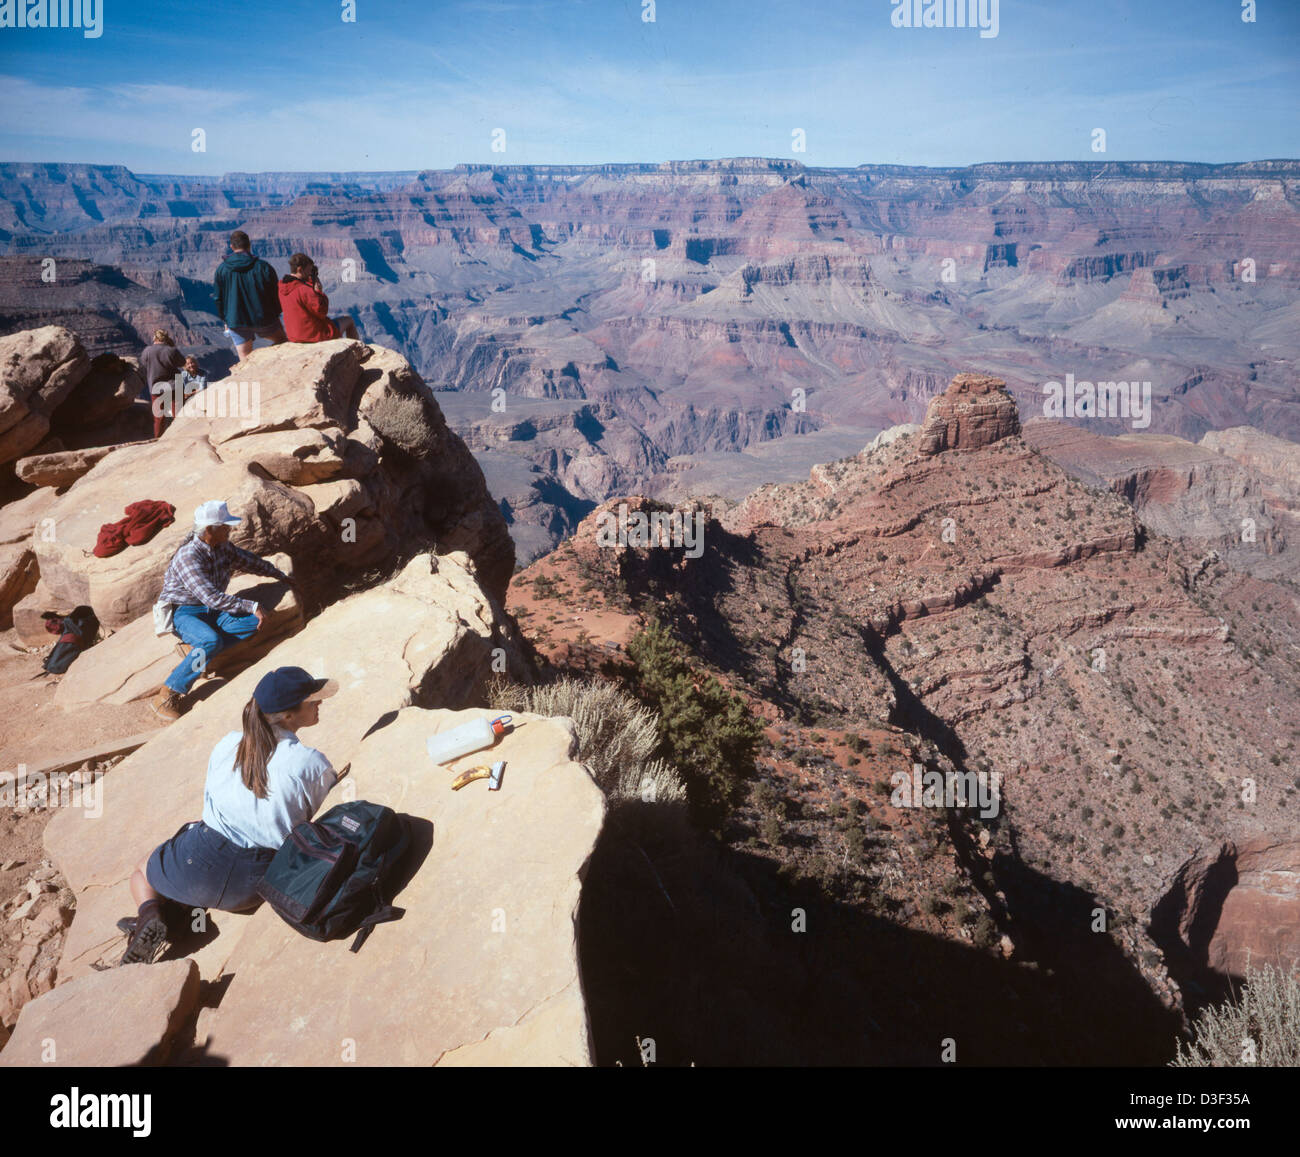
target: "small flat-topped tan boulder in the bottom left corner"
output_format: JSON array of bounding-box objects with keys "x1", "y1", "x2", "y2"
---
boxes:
[{"x1": 0, "y1": 961, "x2": 199, "y2": 1069}]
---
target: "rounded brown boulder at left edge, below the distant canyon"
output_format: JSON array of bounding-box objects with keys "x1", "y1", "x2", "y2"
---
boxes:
[{"x1": 0, "y1": 325, "x2": 90, "y2": 463}]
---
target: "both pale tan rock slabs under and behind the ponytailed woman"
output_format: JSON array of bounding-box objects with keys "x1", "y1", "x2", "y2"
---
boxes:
[{"x1": 14, "y1": 553, "x2": 605, "y2": 1065}]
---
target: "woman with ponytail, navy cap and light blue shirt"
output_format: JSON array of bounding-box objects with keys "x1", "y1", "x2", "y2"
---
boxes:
[{"x1": 118, "y1": 667, "x2": 348, "y2": 965}]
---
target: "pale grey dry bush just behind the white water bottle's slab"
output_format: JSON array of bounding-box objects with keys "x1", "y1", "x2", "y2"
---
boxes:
[{"x1": 489, "y1": 679, "x2": 686, "y2": 803}]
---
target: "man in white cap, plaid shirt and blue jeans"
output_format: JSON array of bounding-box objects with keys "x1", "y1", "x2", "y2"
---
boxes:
[{"x1": 151, "y1": 502, "x2": 298, "y2": 720}]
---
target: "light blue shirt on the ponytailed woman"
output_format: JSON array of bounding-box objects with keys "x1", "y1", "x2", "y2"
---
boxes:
[{"x1": 203, "y1": 727, "x2": 337, "y2": 848}]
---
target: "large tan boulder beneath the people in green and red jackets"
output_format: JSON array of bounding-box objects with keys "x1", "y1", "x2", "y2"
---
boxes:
[{"x1": 25, "y1": 339, "x2": 514, "y2": 627}]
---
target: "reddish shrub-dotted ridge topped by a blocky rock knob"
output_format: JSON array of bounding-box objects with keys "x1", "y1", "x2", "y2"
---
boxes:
[{"x1": 507, "y1": 374, "x2": 1300, "y2": 1063}]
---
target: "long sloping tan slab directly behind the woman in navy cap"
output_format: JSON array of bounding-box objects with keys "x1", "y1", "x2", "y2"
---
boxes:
[{"x1": 46, "y1": 554, "x2": 519, "y2": 979}]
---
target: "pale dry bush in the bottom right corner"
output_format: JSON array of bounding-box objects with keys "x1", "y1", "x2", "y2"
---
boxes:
[{"x1": 1169, "y1": 961, "x2": 1300, "y2": 1069}]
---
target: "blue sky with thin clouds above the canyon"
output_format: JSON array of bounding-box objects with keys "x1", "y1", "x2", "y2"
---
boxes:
[{"x1": 0, "y1": 0, "x2": 1300, "y2": 173}]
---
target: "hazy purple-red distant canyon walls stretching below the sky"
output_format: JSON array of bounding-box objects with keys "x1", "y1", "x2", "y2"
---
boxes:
[{"x1": 0, "y1": 154, "x2": 1300, "y2": 564}]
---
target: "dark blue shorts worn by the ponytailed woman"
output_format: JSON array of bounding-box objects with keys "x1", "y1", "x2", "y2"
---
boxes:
[{"x1": 144, "y1": 820, "x2": 277, "y2": 911}]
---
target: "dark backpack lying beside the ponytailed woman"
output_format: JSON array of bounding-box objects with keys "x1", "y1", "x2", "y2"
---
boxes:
[{"x1": 257, "y1": 800, "x2": 411, "y2": 952}]
